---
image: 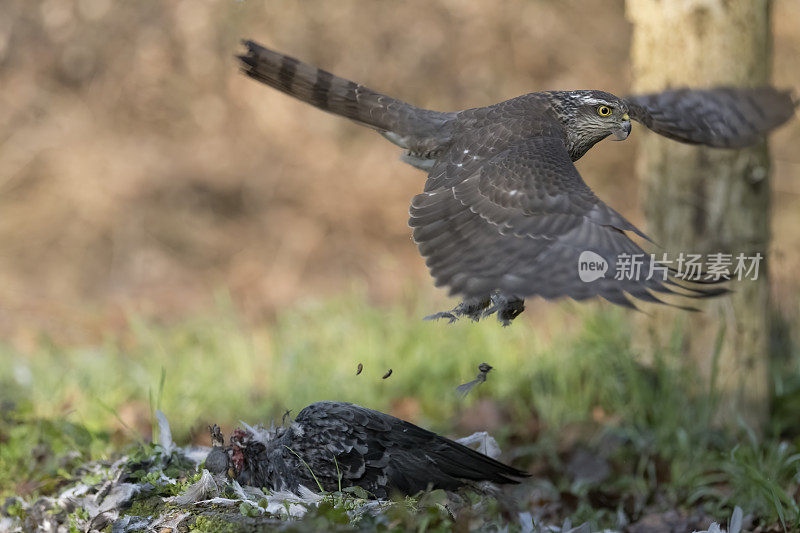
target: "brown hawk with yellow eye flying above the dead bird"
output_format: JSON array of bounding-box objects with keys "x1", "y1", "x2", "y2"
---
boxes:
[{"x1": 239, "y1": 41, "x2": 796, "y2": 325}]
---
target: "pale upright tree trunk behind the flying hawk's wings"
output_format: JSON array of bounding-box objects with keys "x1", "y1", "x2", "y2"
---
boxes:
[{"x1": 627, "y1": 0, "x2": 771, "y2": 430}]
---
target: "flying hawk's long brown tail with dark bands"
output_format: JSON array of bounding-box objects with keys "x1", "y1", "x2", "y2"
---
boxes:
[{"x1": 238, "y1": 41, "x2": 453, "y2": 152}]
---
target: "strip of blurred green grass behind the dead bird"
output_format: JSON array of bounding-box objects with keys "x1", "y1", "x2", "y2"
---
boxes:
[{"x1": 0, "y1": 294, "x2": 800, "y2": 528}]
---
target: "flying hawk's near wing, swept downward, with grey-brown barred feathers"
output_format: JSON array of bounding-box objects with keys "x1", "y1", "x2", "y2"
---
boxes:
[{"x1": 409, "y1": 137, "x2": 720, "y2": 306}]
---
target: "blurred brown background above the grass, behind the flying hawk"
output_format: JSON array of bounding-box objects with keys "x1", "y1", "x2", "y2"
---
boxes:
[{"x1": 0, "y1": 0, "x2": 800, "y2": 339}]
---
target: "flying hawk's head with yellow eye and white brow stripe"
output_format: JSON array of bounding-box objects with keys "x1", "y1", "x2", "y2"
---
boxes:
[{"x1": 549, "y1": 91, "x2": 631, "y2": 161}]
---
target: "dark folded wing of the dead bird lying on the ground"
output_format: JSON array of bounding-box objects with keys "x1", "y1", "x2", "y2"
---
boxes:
[{"x1": 295, "y1": 402, "x2": 527, "y2": 497}]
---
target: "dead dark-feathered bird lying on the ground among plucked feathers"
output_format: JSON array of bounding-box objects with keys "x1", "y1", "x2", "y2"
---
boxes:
[{"x1": 205, "y1": 402, "x2": 528, "y2": 498}]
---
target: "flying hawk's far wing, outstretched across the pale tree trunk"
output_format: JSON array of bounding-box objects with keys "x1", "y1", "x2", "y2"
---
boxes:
[{"x1": 625, "y1": 87, "x2": 796, "y2": 148}]
